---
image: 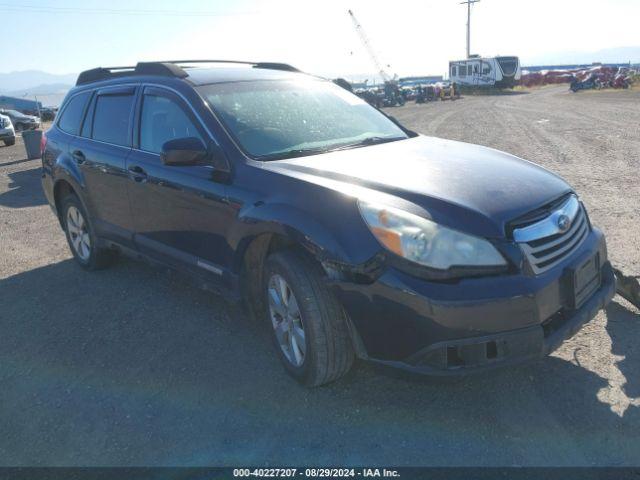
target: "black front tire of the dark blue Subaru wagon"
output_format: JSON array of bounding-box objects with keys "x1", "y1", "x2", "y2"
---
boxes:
[{"x1": 263, "y1": 251, "x2": 354, "y2": 387}]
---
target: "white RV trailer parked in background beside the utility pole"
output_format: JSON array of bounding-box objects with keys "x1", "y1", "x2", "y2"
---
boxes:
[{"x1": 449, "y1": 55, "x2": 522, "y2": 88}]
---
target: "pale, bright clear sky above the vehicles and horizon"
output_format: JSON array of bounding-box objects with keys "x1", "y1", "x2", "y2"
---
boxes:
[{"x1": 0, "y1": 0, "x2": 640, "y2": 77}]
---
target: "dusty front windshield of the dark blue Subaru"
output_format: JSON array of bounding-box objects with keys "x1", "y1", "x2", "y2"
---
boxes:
[{"x1": 198, "y1": 80, "x2": 407, "y2": 160}]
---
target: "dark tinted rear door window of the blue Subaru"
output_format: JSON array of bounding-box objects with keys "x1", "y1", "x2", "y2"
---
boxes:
[{"x1": 92, "y1": 93, "x2": 134, "y2": 146}]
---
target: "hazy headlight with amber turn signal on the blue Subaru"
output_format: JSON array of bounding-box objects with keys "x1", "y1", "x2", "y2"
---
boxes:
[{"x1": 358, "y1": 201, "x2": 507, "y2": 270}]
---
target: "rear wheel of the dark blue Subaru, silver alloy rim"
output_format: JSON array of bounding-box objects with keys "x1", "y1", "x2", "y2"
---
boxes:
[{"x1": 62, "y1": 194, "x2": 115, "y2": 271}]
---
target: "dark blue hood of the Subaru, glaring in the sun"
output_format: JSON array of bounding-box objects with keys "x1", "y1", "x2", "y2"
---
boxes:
[{"x1": 264, "y1": 135, "x2": 571, "y2": 237}]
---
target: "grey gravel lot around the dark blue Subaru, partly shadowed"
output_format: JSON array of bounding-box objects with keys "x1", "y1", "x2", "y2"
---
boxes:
[{"x1": 0, "y1": 87, "x2": 640, "y2": 466}]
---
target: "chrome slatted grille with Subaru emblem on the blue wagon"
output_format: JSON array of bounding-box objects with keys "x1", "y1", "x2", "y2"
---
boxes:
[{"x1": 513, "y1": 195, "x2": 589, "y2": 274}]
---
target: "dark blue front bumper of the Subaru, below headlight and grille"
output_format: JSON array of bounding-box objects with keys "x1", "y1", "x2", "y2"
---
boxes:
[{"x1": 334, "y1": 229, "x2": 615, "y2": 375}]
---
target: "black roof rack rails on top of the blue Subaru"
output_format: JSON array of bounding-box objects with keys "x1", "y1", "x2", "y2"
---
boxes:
[{"x1": 76, "y1": 60, "x2": 300, "y2": 85}]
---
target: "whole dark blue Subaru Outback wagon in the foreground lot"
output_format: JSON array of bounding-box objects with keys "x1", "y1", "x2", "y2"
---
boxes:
[{"x1": 42, "y1": 61, "x2": 615, "y2": 385}]
